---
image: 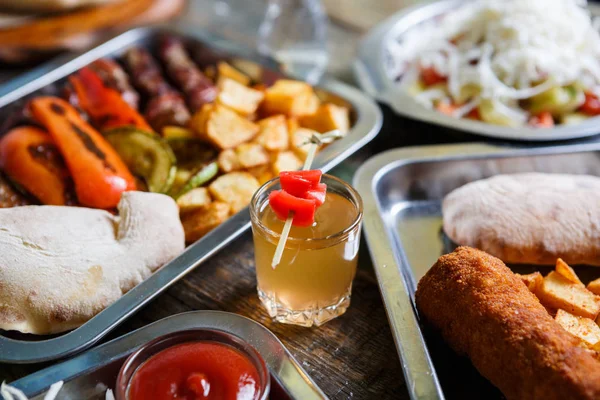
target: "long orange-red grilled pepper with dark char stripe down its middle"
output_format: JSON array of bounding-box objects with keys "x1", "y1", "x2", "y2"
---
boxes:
[{"x1": 30, "y1": 96, "x2": 136, "y2": 209}]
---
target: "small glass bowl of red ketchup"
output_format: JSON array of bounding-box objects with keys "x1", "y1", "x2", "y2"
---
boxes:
[{"x1": 116, "y1": 329, "x2": 270, "y2": 400}]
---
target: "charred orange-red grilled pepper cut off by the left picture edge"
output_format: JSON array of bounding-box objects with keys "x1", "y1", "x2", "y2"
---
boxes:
[{"x1": 0, "y1": 126, "x2": 77, "y2": 205}]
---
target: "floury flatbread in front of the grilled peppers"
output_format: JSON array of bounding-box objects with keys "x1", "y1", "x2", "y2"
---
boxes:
[{"x1": 0, "y1": 192, "x2": 184, "y2": 334}]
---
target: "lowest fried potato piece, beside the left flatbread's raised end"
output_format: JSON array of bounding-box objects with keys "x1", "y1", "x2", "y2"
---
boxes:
[{"x1": 181, "y1": 201, "x2": 231, "y2": 243}]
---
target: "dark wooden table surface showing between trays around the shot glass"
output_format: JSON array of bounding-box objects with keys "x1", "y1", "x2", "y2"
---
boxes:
[{"x1": 0, "y1": 0, "x2": 464, "y2": 400}]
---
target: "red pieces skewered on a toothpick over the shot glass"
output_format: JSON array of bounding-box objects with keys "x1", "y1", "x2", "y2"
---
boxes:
[{"x1": 269, "y1": 170, "x2": 327, "y2": 226}]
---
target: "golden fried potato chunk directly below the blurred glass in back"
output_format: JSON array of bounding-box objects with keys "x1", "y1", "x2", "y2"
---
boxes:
[{"x1": 261, "y1": 79, "x2": 319, "y2": 117}]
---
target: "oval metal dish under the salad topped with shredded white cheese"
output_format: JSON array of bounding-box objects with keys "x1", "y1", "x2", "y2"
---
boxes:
[{"x1": 354, "y1": 0, "x2": 600, "y2": 141}]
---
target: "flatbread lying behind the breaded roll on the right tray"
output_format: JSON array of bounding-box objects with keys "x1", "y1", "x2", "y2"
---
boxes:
[{"x1": 442, "y1": 173, "x2": 600, "y2": 266}]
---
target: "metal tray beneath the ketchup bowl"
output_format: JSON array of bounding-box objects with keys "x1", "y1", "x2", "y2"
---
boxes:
[{"x1": 11, "y1": 311, "x2": 327, "y2": 400}]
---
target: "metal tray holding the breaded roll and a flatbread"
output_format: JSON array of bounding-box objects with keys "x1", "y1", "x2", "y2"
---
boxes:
[{"x1": 354, "y1": 143, "x2": 600, "y2": 399}]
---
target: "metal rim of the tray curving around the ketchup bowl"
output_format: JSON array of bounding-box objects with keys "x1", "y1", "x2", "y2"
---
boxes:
[{"x1": 11, "y1": 310, "x2": 327, "y2": 399}]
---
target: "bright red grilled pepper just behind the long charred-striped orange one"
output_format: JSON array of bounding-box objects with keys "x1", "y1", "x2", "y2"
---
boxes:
[{"x1": 69, "y1": 67, "x2": 151, "y2": 130}]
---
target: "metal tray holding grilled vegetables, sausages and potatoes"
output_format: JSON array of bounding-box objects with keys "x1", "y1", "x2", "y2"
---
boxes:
[{"x1": 0, "y1": 24, "x2": 382, "y2": 363}]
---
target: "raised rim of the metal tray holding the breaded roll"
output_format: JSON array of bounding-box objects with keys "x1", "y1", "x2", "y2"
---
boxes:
[{"x1": 353, "y1": 143, "x2": 600, "y2": 399}]
